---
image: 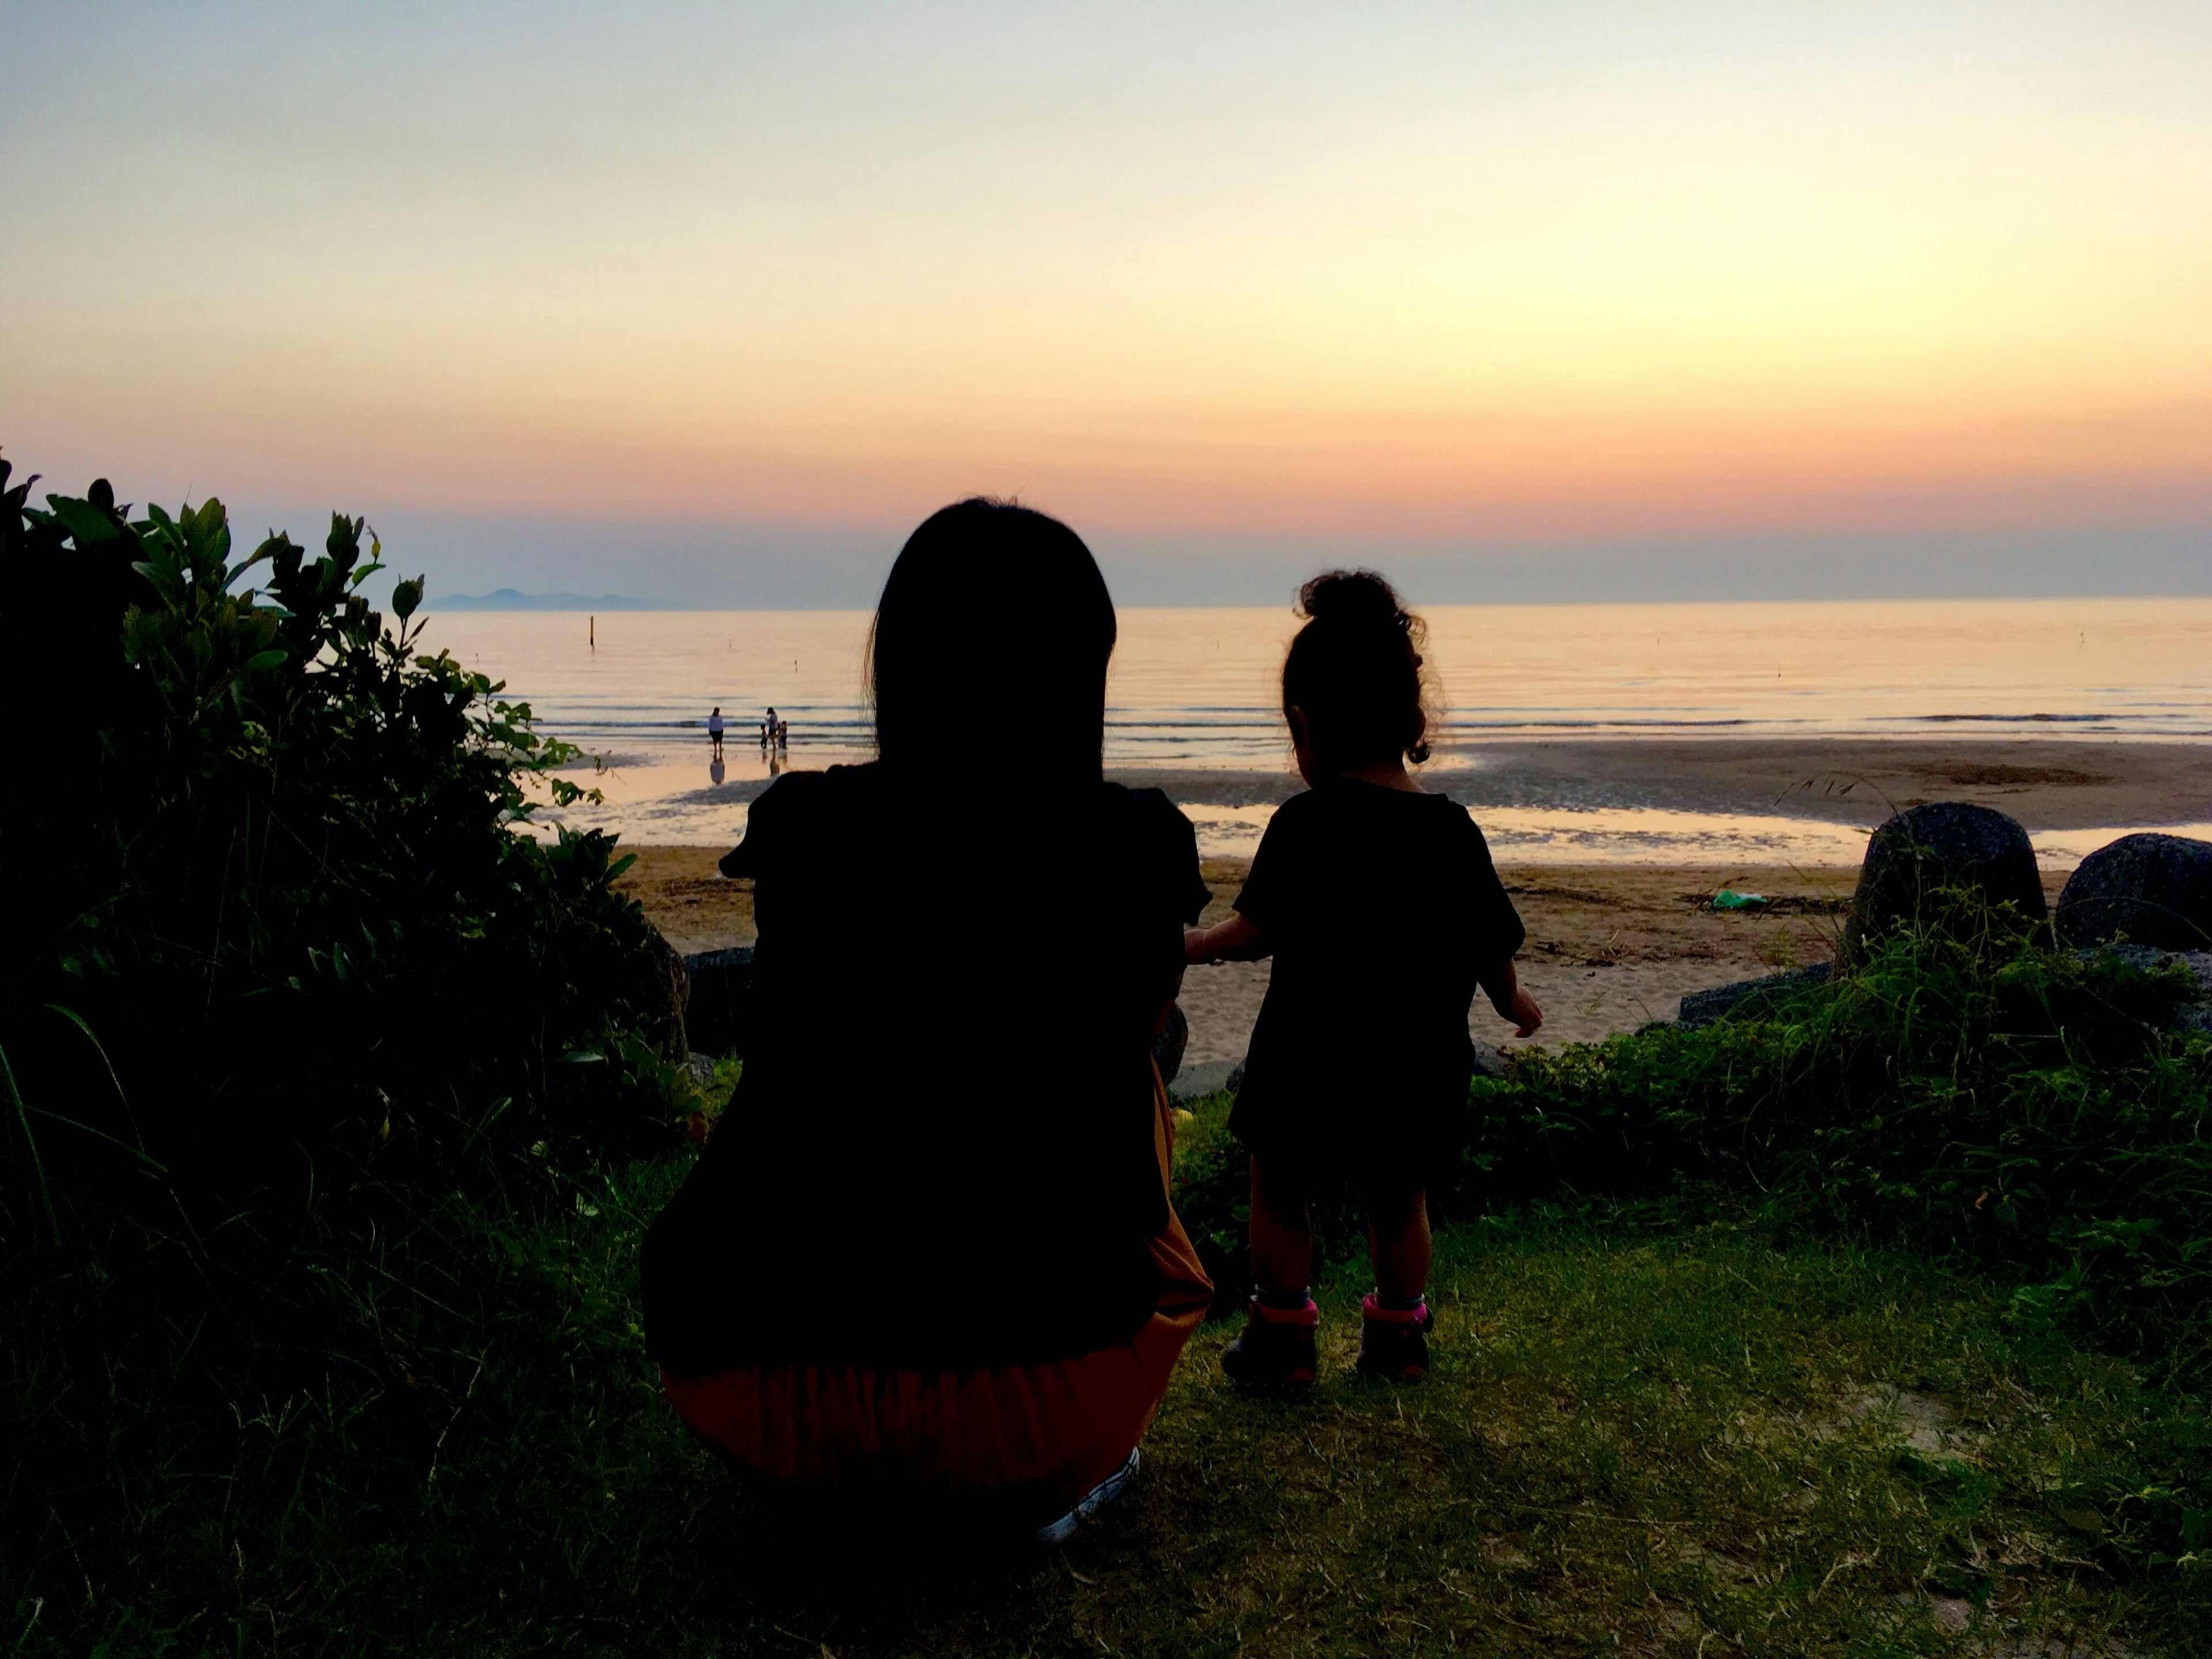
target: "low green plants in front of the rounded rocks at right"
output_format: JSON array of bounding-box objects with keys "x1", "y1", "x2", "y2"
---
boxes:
[{"x1": 1460, "y1": 896, "x2": 2212, "y2": 1376}]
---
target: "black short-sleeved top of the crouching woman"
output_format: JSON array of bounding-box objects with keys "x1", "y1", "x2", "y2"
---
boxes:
[{"x1": 643, "y1": 763, "x2": 1208, "y2": 1376}]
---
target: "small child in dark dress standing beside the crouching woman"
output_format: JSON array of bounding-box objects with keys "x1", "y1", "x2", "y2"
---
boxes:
[{"x1": 1183, "y1": 571, "x2": 1544, "y2": 1385}]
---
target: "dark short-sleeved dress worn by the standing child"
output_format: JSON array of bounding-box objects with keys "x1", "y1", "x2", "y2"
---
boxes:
[{"x1": 1230, "y1": 779, "x2": 1527, "y2": 1183}]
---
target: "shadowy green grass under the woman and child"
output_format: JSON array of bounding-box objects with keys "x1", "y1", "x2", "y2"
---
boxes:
[{"x1": 21, "y1": 1097, "x2": 2205, "y2": 1659}]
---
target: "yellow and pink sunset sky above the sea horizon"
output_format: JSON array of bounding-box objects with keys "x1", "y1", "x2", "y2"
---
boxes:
[{"x1": 0, "y1": 0, "x2": 2212, "y2": 604}]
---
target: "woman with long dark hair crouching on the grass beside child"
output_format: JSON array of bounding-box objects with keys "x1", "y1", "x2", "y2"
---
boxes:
[{"x1": 643, "y1": 500, "x2": 1212, "y2": 1541}]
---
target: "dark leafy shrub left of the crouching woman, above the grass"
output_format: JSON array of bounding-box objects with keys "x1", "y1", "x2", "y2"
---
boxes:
[{"x1": 0, "y1": 471, "x2": 666, "y2": 1199}]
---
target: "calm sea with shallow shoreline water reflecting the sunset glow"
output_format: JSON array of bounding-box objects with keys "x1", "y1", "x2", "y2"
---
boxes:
[{"x1": 425, "y1": 600, "x2": 2212, "y2": 865}]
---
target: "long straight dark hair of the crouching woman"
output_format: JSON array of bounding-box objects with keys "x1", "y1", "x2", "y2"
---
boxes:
[{"x1": 867, "y1": 495, "x2": 1115, "y2": 783}]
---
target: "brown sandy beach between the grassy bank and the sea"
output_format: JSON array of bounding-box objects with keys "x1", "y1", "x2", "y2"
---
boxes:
[{"x1": 622, "y1": 739, "x2": 2212, "y2": 1066}]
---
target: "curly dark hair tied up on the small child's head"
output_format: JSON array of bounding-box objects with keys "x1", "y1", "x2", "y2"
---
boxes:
[{"x1": 1283, "y1": 571, "x2": 1429, "y2": 772}]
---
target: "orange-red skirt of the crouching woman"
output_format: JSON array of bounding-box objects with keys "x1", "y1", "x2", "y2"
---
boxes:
[{"x1": 661, "y1": 1077, "x2": 1212, "y2": 1513}]
